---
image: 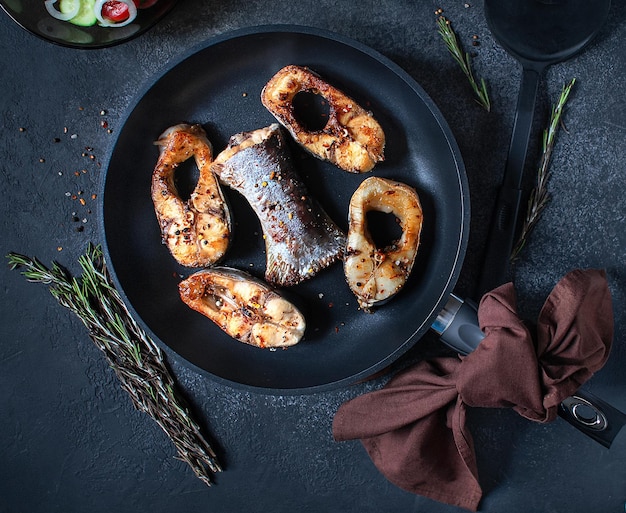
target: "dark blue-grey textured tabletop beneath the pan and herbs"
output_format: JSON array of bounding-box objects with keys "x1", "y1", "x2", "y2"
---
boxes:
[{"x1": 0, "y1": 0, "x2": 626, "y2": 513}]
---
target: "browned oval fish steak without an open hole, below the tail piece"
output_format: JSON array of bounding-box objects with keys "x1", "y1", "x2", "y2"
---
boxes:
[{"x1": 178, "y1": 267, "x2": 306, "y2": 349}]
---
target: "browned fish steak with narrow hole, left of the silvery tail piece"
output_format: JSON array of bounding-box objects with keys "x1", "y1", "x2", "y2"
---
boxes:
[{"x1": 151, "y1": 123, "x2": 232, "y2": 267}]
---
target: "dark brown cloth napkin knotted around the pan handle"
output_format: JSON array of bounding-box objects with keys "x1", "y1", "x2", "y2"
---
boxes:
[{"x1": 333, "y1": 270, "x2": 613, "y2": 511}]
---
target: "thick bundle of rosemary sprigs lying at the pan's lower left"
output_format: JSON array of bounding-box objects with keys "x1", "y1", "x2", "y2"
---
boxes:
[{"x1": 7, "y1": 244, "x2": 222, "y2": 486}]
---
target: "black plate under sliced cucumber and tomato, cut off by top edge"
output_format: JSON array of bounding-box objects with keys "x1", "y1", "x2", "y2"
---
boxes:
[{"x1": 0, "y1": 0, "x2": 177, "y2": 48}]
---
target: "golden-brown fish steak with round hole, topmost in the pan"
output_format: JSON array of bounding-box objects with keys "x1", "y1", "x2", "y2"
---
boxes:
[{"x1": 261, "y1": 65, "x2": 385, "y2": 173}]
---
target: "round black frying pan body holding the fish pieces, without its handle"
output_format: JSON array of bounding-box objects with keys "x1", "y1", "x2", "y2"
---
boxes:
[{"x1": 101, "y1": 26, "x2": 469, "y2": 393}]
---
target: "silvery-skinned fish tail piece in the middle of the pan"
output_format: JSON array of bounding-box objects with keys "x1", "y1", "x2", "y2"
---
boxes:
[{"x1": 211, "y1": 123, "x2": 346, "y2": 286}]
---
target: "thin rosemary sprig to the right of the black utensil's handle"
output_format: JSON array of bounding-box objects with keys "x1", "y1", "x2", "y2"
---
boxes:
[{"x1": 510, "y1": 78, "x2": 576, "y2": 261}]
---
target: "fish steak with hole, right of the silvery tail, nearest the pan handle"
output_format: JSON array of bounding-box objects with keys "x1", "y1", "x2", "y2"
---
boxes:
[{"x1": 344, "y1": 177, "x2": 423, "y2": 312}]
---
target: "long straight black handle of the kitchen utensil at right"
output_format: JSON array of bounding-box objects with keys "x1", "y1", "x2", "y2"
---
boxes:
[{"x1": 475, "y1": 67, "x2": 541, "y2": 297}]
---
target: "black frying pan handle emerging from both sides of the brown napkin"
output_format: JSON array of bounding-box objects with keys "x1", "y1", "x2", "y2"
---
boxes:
[{"x1": 432, "y1": 294, "x2": 626, "y2": 448}]
